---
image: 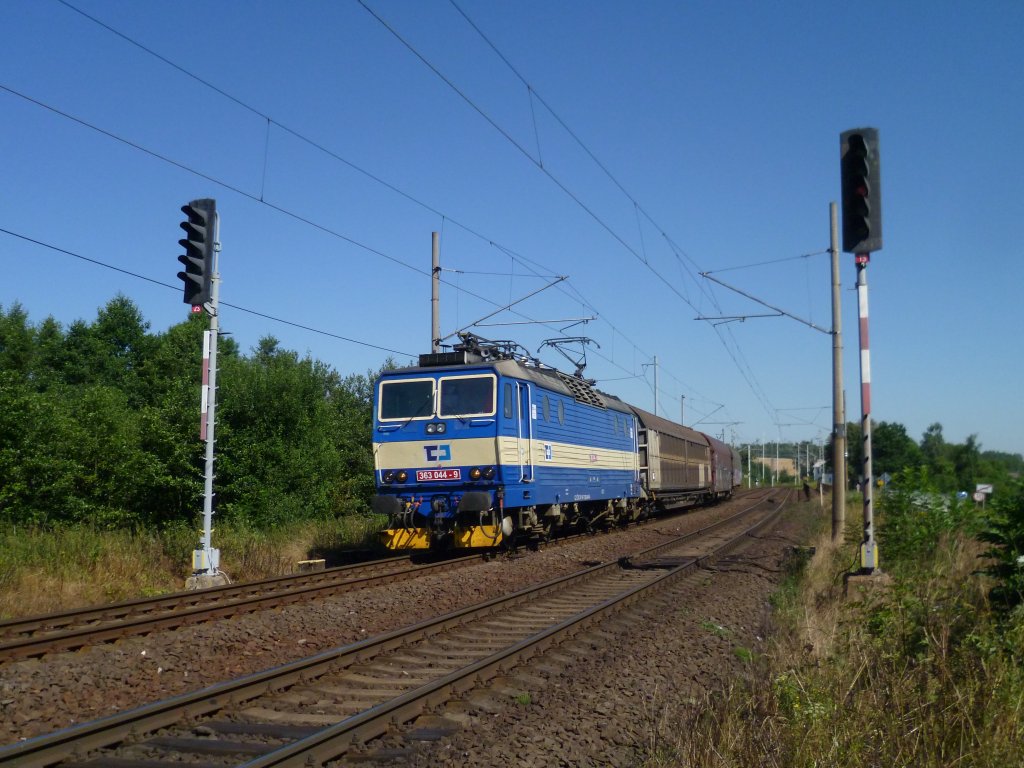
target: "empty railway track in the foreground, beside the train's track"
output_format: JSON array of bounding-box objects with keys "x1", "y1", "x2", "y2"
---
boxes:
[{"x1": 0, "y1": 489, "x2": 782, "y2": 768}]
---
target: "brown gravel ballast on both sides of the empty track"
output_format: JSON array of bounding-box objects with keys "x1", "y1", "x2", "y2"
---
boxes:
[{"x1": 0, "y1": 495, "x2": 819, "y2": 766}]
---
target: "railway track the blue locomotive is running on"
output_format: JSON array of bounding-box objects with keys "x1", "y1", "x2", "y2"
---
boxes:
[{"x1": 0, "y1": 492, "x2": 770, "y2": 665}]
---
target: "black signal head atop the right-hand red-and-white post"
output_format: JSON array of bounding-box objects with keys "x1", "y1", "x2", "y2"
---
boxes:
[{"x1": 840, "y1": 128, "x2": 882, "y2": 254}]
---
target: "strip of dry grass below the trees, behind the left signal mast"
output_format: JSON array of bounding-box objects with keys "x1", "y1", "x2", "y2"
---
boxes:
[{"x1": 0, "y1": 515, "x2": 383, "y2": 618}]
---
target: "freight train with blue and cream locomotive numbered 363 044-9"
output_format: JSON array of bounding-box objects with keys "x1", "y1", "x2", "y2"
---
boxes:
[{"x1": 373, "y1": 334, "x2": 741, "y2": 550}]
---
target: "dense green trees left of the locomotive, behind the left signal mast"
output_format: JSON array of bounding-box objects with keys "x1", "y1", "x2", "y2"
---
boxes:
[{"x1": 0, "y1": 296, "x2": 380, "y2": 527}]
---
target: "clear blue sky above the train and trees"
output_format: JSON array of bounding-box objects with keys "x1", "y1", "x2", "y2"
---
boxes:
[{"x1": 0, "y1": 0, "x2": 1024, "y2": 453}]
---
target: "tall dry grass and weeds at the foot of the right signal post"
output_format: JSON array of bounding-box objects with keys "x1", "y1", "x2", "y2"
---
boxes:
[{"x1": 642, "y1": 493, "x2": 1024, "y2": 768}]
